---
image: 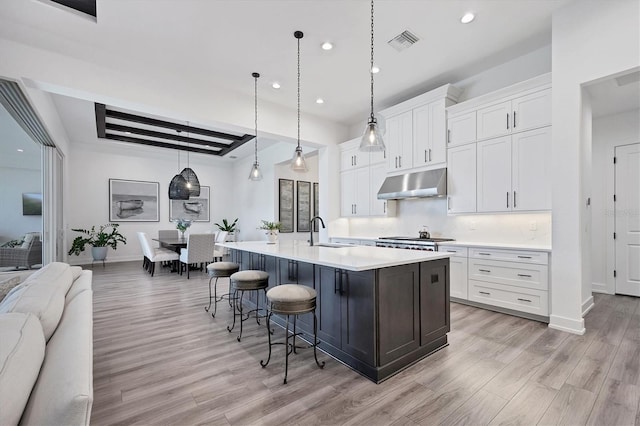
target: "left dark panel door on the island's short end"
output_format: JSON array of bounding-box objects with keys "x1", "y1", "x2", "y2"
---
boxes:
[{"x1": 378, "y1": 263, "x2": 420, "y2": 365}]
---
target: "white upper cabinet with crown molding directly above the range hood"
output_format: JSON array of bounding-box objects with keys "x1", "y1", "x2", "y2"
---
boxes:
[{"x1": 381, "y1": 84, "x2": 460, "y2": 174}]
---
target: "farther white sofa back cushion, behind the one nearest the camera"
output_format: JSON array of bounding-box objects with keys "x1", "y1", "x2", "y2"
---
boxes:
[{"x1": 0, "y1": 262, "x2": 72, "y2": 341}]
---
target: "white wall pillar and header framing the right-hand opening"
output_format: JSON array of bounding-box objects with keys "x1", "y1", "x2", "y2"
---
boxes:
[{"x1": 549, "y1": 0, "x2": 640, "y2": 334}]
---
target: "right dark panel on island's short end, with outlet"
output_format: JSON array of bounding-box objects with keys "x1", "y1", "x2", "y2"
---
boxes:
[{"x1": 420, "y1": 259, "x2": 450, "y2": 345}]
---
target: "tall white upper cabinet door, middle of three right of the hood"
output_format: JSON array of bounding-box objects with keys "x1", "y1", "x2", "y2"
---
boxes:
[{"x1": 477, "y1": 136, "x2": 512, "y2": 212}]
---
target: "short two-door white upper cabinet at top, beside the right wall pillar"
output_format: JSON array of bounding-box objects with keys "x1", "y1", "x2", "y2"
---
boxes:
[{"x1": 477, "y1": 89, "x2": 551, "y2": 140}]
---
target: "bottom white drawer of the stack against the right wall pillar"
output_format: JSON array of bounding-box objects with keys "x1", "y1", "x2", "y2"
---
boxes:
[{"x1": 469, "y1": 280, "x2": 549, "y2": 316}]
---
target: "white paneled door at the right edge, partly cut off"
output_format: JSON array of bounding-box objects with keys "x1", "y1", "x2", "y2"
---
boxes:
[{"x1": 615, "y1": 143, "x2": 640, "y2": 296}]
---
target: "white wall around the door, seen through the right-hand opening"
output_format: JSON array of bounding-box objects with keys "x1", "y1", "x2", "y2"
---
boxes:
[{"x1": 591, "y1": 110, "x2": 640, "y2": 294}]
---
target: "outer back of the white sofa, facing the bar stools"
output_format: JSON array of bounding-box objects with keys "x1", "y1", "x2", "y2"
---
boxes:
[{"x1": 21, "y1": 290, "x2": 93, "y2": 425}]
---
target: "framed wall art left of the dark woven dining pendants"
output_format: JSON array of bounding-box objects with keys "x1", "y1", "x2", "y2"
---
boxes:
[{"x1": 109, "y1": 179, "x2": 160, "y2": 222}]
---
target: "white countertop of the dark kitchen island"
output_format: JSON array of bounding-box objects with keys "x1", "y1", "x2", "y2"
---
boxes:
[{"x1": 216, "y1": 240, "x2": 451, "y2": 271}]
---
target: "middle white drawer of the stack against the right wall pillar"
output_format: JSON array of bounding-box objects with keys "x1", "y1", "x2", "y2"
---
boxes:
[{"x1": 469, "y1": 259, "x2": 549, "y2": 291}]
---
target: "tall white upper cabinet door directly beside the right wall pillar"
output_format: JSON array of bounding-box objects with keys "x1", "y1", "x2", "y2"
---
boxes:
[{"x1": 511, "y1": 127, "x2": 551, "y2": 210}]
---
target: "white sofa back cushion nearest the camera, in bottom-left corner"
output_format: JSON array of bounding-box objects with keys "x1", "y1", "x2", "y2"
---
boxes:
[{"x1": 0, "y1": 313, "x2": 45, "y2": 425}]
